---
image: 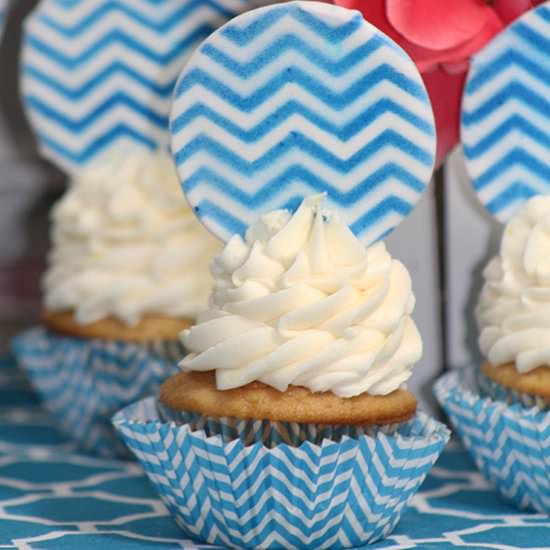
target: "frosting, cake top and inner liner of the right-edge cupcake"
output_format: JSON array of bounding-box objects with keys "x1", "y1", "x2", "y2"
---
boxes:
[{"x1": 476, "y1": 195, "x2": 550, "y2": 409}]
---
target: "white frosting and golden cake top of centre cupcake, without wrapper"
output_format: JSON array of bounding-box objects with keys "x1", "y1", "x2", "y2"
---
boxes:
[{"x1": 161, "y1": 195, "x2": 422, "y2": 434}]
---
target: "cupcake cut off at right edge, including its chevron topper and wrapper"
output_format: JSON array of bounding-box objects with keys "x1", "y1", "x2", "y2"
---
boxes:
[{"x1": 435, "y1": 4, "x2": 550, "y2": 514}]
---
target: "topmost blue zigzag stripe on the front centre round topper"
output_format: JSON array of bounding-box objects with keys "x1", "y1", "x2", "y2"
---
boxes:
[{"x1": 221, "y1": 5, "x2": 364, "y2": 47}]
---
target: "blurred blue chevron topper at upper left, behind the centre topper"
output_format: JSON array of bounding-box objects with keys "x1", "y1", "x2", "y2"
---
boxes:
[{"x1": 21, "y1": 0, "x2": 274, "y2": 171}]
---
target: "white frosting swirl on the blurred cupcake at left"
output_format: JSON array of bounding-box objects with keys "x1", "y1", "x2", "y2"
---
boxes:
[{"x1": 43, "y1": 151, "x2": 221, "y2": 325}]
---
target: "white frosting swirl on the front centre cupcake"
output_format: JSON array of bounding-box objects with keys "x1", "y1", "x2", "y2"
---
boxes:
[{"x1": 180, "y1": 196, "x2": 422, "y2": 397}]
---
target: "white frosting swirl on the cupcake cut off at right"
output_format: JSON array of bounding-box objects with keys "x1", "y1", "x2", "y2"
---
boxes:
[{"x1": 476, "y1": 196, "x2": 550, "y2": 373}]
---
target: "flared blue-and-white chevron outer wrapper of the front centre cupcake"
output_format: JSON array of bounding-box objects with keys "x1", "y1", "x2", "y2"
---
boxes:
[{"x1": 113, "y1": 397, "x2": 449, "y2": 549}]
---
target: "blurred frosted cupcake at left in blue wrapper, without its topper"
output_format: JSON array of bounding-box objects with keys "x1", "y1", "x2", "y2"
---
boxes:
[{"x1": 13, "y1": 152, "x2": 219, "y2": 456}]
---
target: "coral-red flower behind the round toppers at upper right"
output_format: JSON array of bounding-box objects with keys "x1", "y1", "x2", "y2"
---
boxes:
[{"x1": 334, "y1": 0, "x2": 540, "y2": 166}]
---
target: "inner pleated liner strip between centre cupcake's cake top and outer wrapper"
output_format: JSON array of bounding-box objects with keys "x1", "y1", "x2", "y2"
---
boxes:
[{"x1": 158, "y1": 403, "x2": 407, "y2": 449}]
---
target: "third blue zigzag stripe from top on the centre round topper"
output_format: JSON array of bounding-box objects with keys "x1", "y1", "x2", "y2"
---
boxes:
[{"x1": 179, "y1": 64, "x2": 426, "y2": 109}]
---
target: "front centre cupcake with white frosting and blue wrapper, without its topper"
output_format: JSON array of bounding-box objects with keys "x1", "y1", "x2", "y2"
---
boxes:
[{"x1": 114, "y1": 196, "x2": 449, "y2": 548}]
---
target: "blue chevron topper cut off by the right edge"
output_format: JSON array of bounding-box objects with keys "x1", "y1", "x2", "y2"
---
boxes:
[{"x1": 462, "y1": 2, "x2": 550, "y2": 222}]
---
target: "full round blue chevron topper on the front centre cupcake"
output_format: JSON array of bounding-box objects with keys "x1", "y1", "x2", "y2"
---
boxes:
[{"x1": 171, "y1": 2, "x2": 435, "y2": 244}]
